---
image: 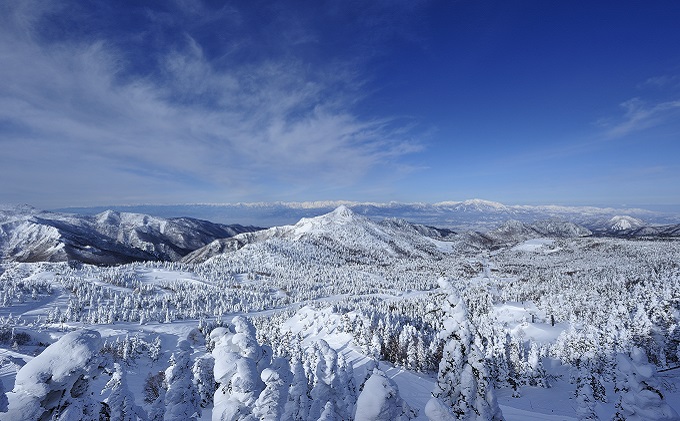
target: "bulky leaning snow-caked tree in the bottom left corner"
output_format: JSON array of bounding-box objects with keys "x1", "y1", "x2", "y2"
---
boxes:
[{"x1": 3, "y1": 330, "x2": 102, "y2": 421}]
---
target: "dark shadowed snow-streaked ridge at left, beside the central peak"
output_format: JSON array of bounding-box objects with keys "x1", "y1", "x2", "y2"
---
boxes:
[{"x1": 0, "y1": 208, "x2": 262, "y2": 264}]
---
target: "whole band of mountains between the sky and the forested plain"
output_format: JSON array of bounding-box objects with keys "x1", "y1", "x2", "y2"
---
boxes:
[{"x1": 0, "y1": 200, "x2": 680, "y2": 264}]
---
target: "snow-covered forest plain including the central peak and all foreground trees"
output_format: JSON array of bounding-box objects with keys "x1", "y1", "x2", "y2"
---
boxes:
[{"x1": 0, "y1": 208, "x2": 680, "y2": 421}]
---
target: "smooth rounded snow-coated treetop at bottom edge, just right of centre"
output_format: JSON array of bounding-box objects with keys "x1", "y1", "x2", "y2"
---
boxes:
[{"x1": 354, "y1": 369, "x2": 415, "y2": 421}]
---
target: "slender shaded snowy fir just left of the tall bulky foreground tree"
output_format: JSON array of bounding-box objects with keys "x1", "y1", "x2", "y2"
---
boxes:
[{"x1": 165, "y1": 340, "x2": 201, "y2": 421}]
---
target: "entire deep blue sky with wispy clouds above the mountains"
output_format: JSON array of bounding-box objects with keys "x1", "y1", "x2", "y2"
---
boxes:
[{"x1": 0, "y1": 0, "x2": 680, "y2": 208}]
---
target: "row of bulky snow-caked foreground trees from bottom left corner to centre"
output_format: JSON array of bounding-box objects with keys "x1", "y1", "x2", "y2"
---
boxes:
[{"x1": 0, "y1": 316, "x2": 415, "y2": 421}]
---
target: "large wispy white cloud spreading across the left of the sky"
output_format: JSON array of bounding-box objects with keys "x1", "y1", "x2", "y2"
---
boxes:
[{"x1": 0, "y1": 2, "x2": 421, "y2": 204}]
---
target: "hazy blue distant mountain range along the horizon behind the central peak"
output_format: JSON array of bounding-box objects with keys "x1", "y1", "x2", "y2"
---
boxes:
[{"x1": 55, "y1": 199, "x2": 680, "y2": 231}]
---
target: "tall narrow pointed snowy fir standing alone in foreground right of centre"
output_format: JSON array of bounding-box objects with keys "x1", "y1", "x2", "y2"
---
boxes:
[{"x1": 425, "y1": 279, "x2": 503, "y2": 421}]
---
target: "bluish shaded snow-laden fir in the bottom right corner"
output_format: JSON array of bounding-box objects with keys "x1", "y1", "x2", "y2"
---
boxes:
[{"x1": 612, "y1": 347, "x2": 680, "y2": 421}]
